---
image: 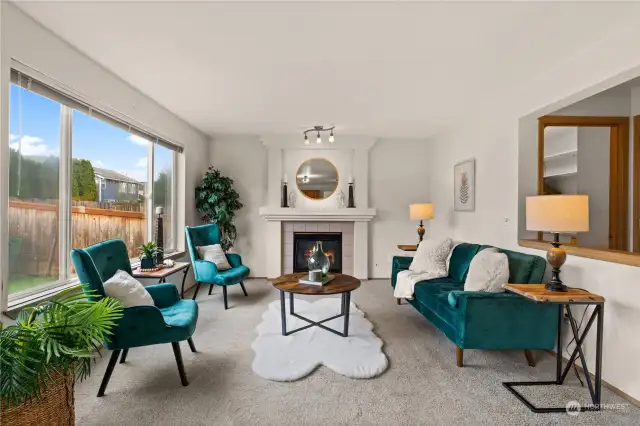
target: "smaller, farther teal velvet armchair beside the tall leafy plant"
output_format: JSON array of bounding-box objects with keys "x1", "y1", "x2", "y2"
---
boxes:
[{"x1": 185, "y1": 224, "x2": 249, "y2": 309}]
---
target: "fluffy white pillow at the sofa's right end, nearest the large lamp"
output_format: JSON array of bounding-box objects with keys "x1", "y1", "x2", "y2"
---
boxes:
[{"x1": 464, "y1": 247, "x2": 509, "y2": 293}]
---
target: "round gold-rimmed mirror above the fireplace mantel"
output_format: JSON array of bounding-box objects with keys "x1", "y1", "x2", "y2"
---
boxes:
[{"x1": 296, "y1": 158, "x2": 338, "y2": 200}]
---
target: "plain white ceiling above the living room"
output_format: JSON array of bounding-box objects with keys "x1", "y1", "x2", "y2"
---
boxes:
[{"x1": 12, "y1": 2, "x2": 640, "y2": 139}]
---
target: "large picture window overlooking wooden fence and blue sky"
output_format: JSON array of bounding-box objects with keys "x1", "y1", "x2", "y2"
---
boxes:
[{"x1": 3, "y1": 70, "x2": 181, "y2": 301}]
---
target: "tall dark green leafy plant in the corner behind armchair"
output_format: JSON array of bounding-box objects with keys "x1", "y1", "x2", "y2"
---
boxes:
[{"x1": 196, "y1": 166, "x2": 244, "y2": 251}]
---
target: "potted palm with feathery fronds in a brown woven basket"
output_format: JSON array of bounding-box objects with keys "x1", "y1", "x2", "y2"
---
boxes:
[{"x1": 0, "y1": 285, "x2": 122, "y2": 426}]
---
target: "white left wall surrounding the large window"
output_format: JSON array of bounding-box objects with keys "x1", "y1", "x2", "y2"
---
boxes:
[{"x1": 0, "y1": 2, "x2": 209, "y2": 300}]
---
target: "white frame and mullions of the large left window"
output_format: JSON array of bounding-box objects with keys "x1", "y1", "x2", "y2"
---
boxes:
[{"x1": 0, "y1": 65, "x2": 183, "y2": 312}]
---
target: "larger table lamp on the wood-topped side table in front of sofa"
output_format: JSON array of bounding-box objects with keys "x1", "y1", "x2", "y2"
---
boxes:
[{"x1": 526, "y1": 195, "x2": 589, "y2": 291}]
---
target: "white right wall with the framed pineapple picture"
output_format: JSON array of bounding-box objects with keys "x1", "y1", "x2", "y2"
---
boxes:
[{"x1": 431, "y1": 18, "x2": 640, "y2": 399}]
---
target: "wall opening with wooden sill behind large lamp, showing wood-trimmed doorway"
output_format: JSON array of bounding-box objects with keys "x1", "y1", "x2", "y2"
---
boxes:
[{"x1": 518, "y1": 75, "x2": 640, "y2": 266}]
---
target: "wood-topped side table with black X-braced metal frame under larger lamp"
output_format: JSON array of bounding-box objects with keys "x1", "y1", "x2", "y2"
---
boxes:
[{"x1": 502, "y1": 284, "x2": 604, "y2": 413}]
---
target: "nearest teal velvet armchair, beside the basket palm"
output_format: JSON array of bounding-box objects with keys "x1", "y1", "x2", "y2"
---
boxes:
[{"x1": 71, "y1": 240, "x2": 198, "y2": 397}]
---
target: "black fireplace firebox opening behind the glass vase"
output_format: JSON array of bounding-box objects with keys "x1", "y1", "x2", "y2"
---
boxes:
[{"x1": 293, "y1": 232, "x2": 342, "y2": 273}]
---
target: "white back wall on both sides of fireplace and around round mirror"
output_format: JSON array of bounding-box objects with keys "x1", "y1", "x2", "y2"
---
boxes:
[{"x1": 210, "y1": 135, "x2": 429, "y2": 278}]
